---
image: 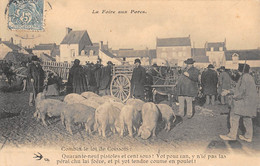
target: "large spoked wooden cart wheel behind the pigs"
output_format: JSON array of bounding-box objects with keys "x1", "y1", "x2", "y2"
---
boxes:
[{"x1": 110, "y1": 74, "x2": 131, "y2": 102}]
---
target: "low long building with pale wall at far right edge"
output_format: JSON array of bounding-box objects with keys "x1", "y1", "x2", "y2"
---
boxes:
[{"x1": 225, "y1": 49, "x2": 260, "y2": 69}]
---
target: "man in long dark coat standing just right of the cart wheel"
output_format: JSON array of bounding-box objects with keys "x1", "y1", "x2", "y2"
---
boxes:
[{"x1": 131, "y1": 59, "x2": 145, "y2": 100}]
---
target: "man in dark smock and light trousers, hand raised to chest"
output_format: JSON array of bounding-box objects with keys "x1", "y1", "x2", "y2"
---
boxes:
[{"x1": 177, "y1": 58, "x2": 199, "y2": 118}]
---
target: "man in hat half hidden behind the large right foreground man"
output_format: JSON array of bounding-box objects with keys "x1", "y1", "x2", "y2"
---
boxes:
[{"x1": 218, "y1": 66, "x2": 231, "y2": 105}]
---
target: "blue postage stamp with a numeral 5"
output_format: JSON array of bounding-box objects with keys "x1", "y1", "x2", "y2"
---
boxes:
[{"x1": 8, "y1": 0, "x2": 44, "y2": 31}]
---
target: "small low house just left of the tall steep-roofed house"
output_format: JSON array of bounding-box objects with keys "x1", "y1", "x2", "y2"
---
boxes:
[{"x1": 32, "y1": 43, "x2": 60, "y2": 58}]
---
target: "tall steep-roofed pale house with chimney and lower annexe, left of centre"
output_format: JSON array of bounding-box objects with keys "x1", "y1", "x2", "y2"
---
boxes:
[{"x1": 56, "y1": 28, "x2": 121, "y2": 65}]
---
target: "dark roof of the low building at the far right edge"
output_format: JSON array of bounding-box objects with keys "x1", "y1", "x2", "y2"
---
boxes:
[{"x1": 225, "y1": 49, "x2": 260, "y2": 61}]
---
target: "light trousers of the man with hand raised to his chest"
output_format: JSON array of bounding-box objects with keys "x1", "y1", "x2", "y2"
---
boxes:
[{"x1": 178, "y1": 96, "x2": 193, "y2": 117}]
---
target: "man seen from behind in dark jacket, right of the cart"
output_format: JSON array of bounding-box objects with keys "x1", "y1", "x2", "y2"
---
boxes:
[{"x1": 201, "y1": 64, "x2": 218, "y2": 105}]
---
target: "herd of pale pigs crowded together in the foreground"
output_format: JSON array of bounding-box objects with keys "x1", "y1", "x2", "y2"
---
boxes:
[{"x1": 34, "y1": 92, "x2": 176, "y2": 139}]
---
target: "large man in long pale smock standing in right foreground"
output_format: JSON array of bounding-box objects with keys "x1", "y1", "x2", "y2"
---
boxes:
[{"x1": 220, "y1": 64, "x2": 258, "y2": 142}]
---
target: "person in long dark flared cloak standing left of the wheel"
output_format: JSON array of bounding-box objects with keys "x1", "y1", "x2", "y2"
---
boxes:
[{"x1": 68, "y1": 59, "x2": 87, "y2": 94}]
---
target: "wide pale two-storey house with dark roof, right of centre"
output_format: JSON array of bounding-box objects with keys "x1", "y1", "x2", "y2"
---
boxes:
[{"x1": 156, "y1": 36, "x2": 191, "y2": 66}]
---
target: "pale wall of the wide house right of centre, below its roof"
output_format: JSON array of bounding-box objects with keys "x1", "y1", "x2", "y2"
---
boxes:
[{"x1": 156, "y1": 46, "x2": 191, "y2": 66}]
